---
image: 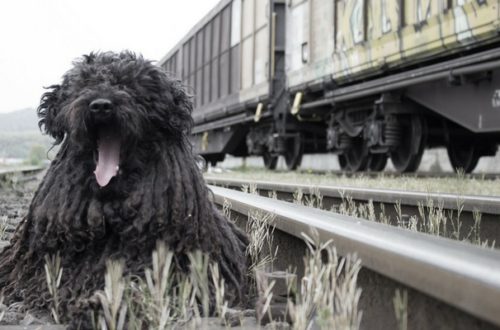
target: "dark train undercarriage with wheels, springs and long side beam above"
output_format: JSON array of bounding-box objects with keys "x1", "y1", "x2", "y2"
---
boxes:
[{"x1": 239, "y1": 47, "x2": 500, "y2": 173}]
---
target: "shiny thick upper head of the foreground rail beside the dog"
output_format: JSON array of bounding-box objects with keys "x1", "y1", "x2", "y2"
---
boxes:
[{"x1": 209, "y1": 186, "x2": 500, "y2": 325}]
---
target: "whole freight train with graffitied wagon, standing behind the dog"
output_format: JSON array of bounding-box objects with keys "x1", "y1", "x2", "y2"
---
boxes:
[{"x1": 159, "y1": 0, "x2": 500, "y2": 172}]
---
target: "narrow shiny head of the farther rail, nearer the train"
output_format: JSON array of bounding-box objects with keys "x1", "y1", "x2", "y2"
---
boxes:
[{"x1": 205, "y1": 176, "x2": 500, "y2": 214}]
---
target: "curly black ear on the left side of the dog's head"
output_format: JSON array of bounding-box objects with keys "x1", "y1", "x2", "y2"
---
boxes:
[{"x1": 37, "y1": 85, "x2": 65, "y2": 144}]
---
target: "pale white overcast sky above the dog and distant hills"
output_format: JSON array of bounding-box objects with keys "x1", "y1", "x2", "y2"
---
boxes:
[{"x1": 0, "y1": 0, "x2": 220, "y2": 112}]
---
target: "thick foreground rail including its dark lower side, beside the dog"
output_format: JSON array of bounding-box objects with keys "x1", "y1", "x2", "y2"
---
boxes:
[{"x1": 207, "y1": 184, "x2": 500, "y2": 329}]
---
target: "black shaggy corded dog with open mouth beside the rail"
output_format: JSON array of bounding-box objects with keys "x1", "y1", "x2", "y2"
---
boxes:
[{"x1": 0, "y1": 52, "x2": 247, "y2": 321}]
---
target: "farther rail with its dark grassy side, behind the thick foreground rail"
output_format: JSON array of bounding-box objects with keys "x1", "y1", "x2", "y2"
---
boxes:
[{"x1": 205, "y1": 176, "x2": 500, "y2": 243}]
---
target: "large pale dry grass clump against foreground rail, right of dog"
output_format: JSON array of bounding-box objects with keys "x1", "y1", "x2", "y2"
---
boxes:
[{"x1": 288, "y1": 231, "x2": 362, "y2": 330}]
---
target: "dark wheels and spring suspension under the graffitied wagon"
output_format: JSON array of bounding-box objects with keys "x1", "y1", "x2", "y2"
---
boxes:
[{"x1": 327, "y1": 95, "x2": 498, "y2": 173}]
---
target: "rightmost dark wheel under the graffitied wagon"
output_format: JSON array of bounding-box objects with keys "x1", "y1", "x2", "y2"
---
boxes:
[{"x1": 447, "y1": 140, "x2": 481, "y2": 173}]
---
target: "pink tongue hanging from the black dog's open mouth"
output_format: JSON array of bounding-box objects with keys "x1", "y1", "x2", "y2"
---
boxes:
[{"x1": 94, "y1": 127, "x2": 120, "y2": 187}]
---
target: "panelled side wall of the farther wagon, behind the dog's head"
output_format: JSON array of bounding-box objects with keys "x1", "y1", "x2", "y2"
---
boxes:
[{"x1": 160, "y1": 0, "x2": 270, "y2": 123}]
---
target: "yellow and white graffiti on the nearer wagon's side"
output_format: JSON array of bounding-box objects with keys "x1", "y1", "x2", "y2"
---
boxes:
[{"x1": 333, "y1": 0, "x2": 499, "y2": 80}]
